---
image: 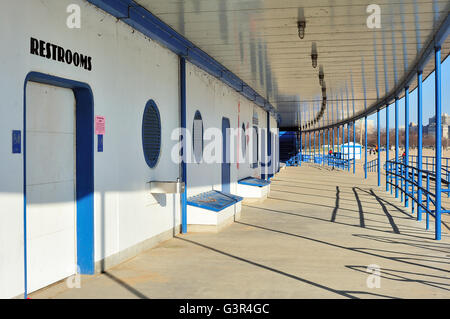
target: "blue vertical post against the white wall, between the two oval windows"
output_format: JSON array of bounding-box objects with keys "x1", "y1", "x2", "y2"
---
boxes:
[{"x1": 180, "y1": 57, "x2": 188, "y2": 234}]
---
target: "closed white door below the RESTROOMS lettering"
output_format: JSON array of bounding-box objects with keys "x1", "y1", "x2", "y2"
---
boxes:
[{"x1": 25, "y1": 82, "x2": 76, "y2": 292}]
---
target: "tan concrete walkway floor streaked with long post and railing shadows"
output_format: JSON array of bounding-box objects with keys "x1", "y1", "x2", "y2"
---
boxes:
[{"x1": 30, "y1": 165, "x2": 450, "y2": 299}]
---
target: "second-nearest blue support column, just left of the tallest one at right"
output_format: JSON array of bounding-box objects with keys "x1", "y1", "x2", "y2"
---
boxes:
[{"x1": 417, "y1": 71, "x2": 423, "y2": 221}]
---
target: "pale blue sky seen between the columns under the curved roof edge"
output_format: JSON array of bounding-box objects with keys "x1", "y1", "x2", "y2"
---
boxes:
[{"x1": 367, "y1": 55, "x2": 450, "y2": 129}]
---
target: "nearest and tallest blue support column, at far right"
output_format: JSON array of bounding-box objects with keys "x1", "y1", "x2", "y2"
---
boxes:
[{"x1": 434, "y1": 46, "x2": 442, "y2": 240}]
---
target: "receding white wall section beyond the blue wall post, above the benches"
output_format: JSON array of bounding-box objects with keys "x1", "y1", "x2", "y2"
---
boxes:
[{"x1": 186, "y1": 63, "x2": 276, "y2": 197}]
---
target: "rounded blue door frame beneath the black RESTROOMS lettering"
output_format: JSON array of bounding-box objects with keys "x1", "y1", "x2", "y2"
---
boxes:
[{"x1": 23, "y1": 72, "x2": 94, "y2": 298}]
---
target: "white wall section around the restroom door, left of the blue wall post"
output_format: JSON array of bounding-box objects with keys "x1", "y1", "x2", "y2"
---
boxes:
[{"x1": 0, "y1": 0, "x2": 179, "y2": 297}]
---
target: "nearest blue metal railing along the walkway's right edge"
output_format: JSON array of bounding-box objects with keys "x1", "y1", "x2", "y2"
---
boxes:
[{"x1": 385, "y1": 160, "x2": 450, "y2": 237}]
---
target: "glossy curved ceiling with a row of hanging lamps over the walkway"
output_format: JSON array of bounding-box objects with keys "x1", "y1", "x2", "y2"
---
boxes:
[{"x1": 136, "y1": 0, "x2": 450, "y2": 129}]
